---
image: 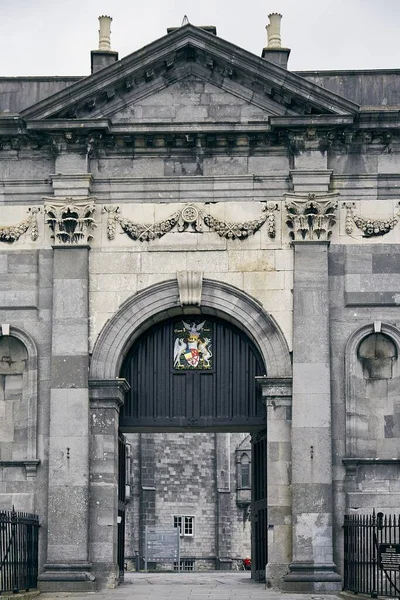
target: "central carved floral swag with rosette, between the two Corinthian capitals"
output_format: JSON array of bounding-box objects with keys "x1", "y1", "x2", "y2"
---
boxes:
[{"x1": 103, "y1": 202, "x2": 278, "y2": 242}]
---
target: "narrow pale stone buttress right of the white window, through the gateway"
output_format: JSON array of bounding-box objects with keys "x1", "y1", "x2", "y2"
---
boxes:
[{"x1": 214, "y1": 433, "x2": 232, "y2": 570}]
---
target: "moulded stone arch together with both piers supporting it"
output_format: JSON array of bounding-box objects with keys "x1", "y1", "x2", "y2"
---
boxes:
[{"x1": 89, "y1": 279, "x2": 291, "y2": 585}]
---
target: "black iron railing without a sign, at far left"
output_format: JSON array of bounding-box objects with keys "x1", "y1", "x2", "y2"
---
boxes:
[{"x1": 0, "y1": 509, "x2": 39, "y2": 593}]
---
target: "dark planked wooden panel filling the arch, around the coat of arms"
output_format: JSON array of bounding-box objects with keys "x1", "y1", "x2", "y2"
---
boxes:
[{"x1": 120, "y1": 315, "x2": 266, "y2": 433}]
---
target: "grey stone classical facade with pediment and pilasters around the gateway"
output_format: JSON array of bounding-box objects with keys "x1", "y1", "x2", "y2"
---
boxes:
[{"x1": 0, "y1": 15, "x2": 400, "y2": 591}]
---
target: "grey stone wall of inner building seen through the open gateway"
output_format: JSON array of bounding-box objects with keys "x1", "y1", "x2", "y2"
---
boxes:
[{"x1": 125, "y1": 433, "x2": 251, "y2": 570}]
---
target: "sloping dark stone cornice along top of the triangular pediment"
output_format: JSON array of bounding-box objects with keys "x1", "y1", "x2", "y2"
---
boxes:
[{"x1": 21, "y1": 24, "x2": 359, "y2": 119}]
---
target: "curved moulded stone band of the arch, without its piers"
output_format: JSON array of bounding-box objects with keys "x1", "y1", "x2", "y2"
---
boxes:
[{"x1": 90, "y1": 279, "x2": 291, "y2": 379}]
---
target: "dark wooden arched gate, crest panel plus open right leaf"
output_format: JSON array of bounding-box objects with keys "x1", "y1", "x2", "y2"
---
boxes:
[{"x1": 119, "y1": 314, "x2": 267, "y2": 579}]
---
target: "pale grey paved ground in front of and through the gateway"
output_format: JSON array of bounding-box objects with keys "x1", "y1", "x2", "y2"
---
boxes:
[{"x1": 38, "y1": 571, "x2": 338, "y2": 600}]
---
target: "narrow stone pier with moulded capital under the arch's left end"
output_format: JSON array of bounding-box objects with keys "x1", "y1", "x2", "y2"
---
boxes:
[{"x1": 89, "y1": 379, "x2": 129, "y2": 587}]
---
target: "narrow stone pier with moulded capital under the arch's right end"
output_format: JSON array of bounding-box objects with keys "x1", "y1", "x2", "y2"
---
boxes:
[{"x1": 256, "y1": 377, "x2": 292, "y2": 589}]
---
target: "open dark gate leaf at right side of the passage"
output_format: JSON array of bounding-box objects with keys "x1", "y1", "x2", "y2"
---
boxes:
[{"x1": 251, "y1": 429, "x2": 268, "y2": 581}]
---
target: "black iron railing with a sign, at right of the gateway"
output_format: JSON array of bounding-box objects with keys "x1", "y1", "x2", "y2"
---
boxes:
[{"x1": 344, "y1": 511, "x2": 400, "y2": 598}]
